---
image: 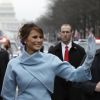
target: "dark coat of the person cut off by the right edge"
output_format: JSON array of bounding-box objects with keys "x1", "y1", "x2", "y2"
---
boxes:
[{"x1": 73, "y1": 49, "x2": 100, "y2": 100}]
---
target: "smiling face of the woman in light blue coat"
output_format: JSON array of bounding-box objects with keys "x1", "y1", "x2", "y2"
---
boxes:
[{"x1": 24, "y1": 29, "x2": 44, "y2": 54}]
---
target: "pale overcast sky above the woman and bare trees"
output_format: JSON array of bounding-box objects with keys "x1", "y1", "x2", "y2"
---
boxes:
[{"x1": 0, "y1": 0, "x2": 48, "y2": 20}]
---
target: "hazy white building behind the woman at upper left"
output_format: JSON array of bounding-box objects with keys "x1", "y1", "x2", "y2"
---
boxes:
[{"x1": 0, "y1": 0, "x2": 20, "y2": 40}]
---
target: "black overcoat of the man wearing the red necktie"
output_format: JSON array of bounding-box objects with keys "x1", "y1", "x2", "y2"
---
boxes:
[{"x1": 49, "y1": 42, "x2": 85, "y2": 100}]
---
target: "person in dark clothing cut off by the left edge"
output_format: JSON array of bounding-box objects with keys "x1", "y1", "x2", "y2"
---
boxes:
[{"x1": 0, "y1": 47, "x2": 9, "y2": 100}]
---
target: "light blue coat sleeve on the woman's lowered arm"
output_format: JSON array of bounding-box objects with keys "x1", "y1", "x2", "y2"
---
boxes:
[{"x1": 1, "y1": 63, "x2": 16, "y2": 100}]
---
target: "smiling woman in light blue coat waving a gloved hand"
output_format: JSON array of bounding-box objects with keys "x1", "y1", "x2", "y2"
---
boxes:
[{"x1": 1, "y1": 23, "x2": 96, "y2": 100}]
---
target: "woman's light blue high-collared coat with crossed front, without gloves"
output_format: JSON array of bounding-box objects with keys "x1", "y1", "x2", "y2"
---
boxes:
[{"x1": 2, "y1": 51, "x2": 91, "y2": 100}]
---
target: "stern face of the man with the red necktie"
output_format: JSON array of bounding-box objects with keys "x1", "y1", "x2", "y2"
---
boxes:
[{"x1": 60, "y1": 25, "x2": 72, "y2": 44}]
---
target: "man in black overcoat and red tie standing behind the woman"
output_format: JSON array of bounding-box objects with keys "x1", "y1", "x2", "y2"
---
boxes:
[{"x1": 48, "y1": 24, "x2": 86, "y2": 100}]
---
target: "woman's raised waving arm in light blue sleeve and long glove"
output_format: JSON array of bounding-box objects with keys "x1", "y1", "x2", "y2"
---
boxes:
[{"x1": 55, "y1": 34, "x2": 96, "y2": 82}]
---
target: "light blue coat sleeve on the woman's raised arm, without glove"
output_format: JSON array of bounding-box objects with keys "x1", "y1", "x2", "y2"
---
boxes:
[{"x1": 52, "y1": 56, "x2": 91, "y2": 82}]
